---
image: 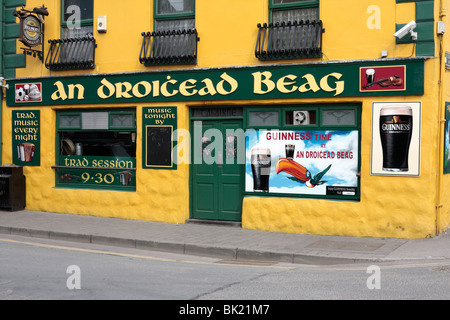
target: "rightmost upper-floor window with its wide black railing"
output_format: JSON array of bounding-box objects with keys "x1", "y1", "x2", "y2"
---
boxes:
[{"x1": 255, "y1": 0, "x2": 324, "y2": 60}]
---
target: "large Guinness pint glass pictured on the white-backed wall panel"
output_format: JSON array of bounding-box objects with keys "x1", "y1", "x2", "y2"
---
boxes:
[{"x1": 380, "y1": 105, "x2": 413, "y2": 172}]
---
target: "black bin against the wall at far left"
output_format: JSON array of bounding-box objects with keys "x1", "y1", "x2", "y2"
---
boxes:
[{"x1": 0, "y1": 166, "x2": 26, "y2": 211}]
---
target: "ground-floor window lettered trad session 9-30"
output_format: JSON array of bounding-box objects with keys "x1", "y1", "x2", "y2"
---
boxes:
[{"x1": 54, "y1": 109, "x2": 136, "y2": 191}]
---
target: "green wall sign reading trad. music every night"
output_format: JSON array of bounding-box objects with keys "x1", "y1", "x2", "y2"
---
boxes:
[{"x1": 12, "y1": 110, "x2": 41, "y2": 166}]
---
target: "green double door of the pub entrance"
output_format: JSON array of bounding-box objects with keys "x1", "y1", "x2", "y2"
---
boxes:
[{"x1": 191, "y1": 120, "x2": 245, "y2": 221}]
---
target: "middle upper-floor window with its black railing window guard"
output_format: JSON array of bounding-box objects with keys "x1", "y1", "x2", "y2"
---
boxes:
[{"x1": 139, "y1": 0, "x2": 199, "y2": 66}]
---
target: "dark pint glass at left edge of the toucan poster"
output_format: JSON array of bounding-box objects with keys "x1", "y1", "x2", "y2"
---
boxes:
[{"x1": 250, "y1": 147, "x2": 272, "y2": 192}]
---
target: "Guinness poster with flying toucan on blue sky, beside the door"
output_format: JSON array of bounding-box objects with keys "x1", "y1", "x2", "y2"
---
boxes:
[{"x1": 245, "y1": 130, "x2": 359, "y2": 199}]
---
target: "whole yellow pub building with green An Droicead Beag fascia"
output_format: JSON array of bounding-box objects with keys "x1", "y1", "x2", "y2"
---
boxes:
[{"x1": 0, "y1": 0, "x2": 450, "y2": 238}]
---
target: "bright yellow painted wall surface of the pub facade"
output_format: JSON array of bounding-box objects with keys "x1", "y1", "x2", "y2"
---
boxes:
[{"x1": 3, "y1": 0, "x2": 450, "y2": 238}]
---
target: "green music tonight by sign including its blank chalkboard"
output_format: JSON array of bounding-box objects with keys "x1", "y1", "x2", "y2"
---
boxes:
[{"x1": 142, "y1": 107, "x2": 177, "y2": 169}]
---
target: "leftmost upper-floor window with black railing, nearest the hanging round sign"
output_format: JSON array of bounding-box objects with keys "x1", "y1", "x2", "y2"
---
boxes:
[{"x1": 45, "y1": 0, "x2": 97, "y2": 70}]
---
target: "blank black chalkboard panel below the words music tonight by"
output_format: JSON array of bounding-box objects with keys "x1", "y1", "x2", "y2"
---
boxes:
[{"x1": 146, "y1": 126, "x2": 173, "y2": 167}]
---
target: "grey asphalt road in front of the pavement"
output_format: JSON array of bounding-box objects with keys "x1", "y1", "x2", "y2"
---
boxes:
[{"x1": 0, "y1": 235, "x2": 450, "y2": 302}]
